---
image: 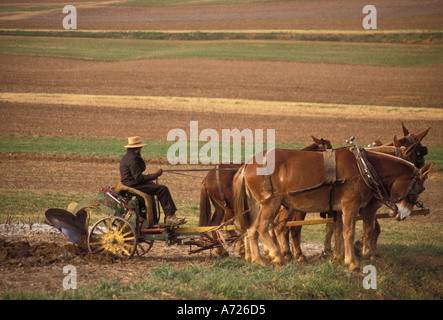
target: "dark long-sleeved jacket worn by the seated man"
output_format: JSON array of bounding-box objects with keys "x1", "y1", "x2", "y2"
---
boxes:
[{"x1": 120, "y1": 148, "x2": 158, "y2": 187}]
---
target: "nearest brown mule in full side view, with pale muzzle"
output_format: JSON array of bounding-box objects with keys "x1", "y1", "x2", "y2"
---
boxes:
[{"x1": 234, "y1": 148, "x2": 433, "y2": 270}]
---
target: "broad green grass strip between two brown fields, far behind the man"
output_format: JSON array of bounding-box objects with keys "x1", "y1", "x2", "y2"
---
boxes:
[{"x1": 0, "y1": 37, "x2": 443, "y2": 66}]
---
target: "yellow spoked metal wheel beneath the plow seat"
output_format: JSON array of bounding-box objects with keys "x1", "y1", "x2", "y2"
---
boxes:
[{"x1": 88, "y1": 217, "x2": 137, "y2": 258}]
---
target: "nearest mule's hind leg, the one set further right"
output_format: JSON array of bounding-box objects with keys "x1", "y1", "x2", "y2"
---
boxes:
[{"x1": 257, "y1": 199, "x2": 282, "y2": 264}]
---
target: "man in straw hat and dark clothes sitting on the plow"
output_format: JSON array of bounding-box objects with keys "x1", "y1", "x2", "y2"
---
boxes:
[{"x1": 120, "y1": 136, "x2": 185, "y2": 225}]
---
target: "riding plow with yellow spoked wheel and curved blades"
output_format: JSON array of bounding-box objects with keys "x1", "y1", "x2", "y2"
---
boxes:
[{"x1": 45, "y1": 186, "x2": 430, "y2": 258}]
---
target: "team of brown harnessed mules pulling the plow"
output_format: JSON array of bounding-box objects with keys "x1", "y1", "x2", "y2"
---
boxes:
[{"x1": 199, "y1": 123, "x2": 433, "y2": 270}]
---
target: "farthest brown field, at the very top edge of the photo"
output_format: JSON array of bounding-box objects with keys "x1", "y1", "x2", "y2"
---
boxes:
[{"x1": 0, "y1": 0, "x2": 443, "y2": 30}]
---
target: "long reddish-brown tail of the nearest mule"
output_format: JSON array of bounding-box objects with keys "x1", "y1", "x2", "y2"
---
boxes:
[{"x1": 232, "y1": 166, "x2": 249, "y2": 230}]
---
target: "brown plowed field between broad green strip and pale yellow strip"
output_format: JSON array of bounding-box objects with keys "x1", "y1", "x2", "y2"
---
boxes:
[{"x1": 0, "y1": 54, "x2": 443, "y2": 107}]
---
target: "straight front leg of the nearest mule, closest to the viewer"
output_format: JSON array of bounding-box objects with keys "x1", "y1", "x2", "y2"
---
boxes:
[{"x1": 342, "y1": 203, "x2": 360, "y2": 271}]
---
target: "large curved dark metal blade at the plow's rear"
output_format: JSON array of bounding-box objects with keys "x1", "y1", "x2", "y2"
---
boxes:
[{"x1": 45, "y1": 209, "x2": 88, "y2": 243}]
